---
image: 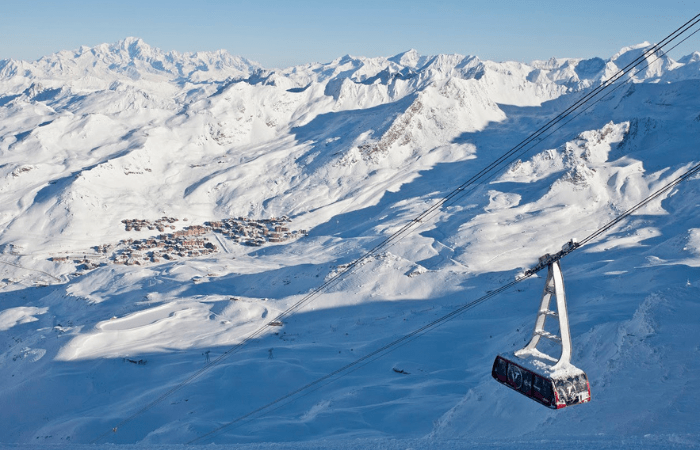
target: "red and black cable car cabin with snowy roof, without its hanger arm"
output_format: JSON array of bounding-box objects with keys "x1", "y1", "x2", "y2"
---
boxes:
[{"x1": 491, "y1": 353, "x2": 591, "y2": 409}]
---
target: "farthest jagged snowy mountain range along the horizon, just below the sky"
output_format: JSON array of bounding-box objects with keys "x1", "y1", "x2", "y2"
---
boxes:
[{"x1": 0, "y1": 37, "x2": 694, "y2": 99}]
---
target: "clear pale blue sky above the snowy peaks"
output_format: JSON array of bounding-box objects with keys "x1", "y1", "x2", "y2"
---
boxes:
[{"x1": 0, "y1": 0, "x2": 700, "y2": 68}]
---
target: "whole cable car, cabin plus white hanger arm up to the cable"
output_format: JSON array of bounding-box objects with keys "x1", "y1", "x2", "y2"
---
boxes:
[{"x1": 491, "y1": 241, "x2": 591, "y2": 409}]
